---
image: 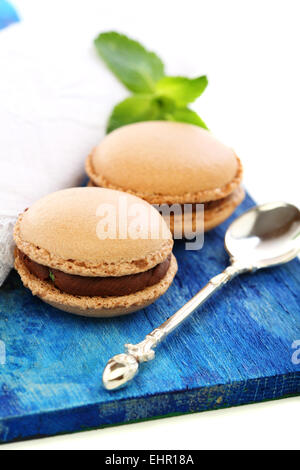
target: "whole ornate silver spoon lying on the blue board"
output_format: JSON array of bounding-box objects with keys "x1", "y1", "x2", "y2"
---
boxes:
[{"x1": 103, "y1": 202, "x2": 300, "y2": 390}]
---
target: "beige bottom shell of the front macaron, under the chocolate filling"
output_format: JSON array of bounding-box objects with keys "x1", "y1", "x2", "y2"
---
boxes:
[{"x1": 15, "y1": 254, "x2": 177, "y2": 317}]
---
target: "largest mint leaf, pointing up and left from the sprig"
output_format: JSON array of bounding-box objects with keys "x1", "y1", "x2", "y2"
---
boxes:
[{"x1": 94, "y1": 32, "x2": 164, "y2": 93}]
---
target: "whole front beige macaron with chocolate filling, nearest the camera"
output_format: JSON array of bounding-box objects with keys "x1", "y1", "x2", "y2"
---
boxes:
[{"x1": 14, "y1": 188, "x2": 177, "y2": 317}]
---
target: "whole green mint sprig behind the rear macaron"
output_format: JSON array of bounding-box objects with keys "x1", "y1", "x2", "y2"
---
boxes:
[{"x1": 94, "y1": 32, "x2": 208, "y2": 133}]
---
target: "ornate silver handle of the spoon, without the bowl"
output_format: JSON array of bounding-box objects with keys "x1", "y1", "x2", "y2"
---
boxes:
[{"x1": 103, "y1": 261, "x2": 247, "y2": 390}]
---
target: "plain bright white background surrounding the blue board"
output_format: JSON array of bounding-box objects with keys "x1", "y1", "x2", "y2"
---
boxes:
[{"x1": 1, "y1": 0, "x2": 300, "y2": 449}]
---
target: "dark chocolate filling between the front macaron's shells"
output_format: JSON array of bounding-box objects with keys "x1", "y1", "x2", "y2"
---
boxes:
[{"x1": 19, "y1": 250, "x2": 171, "y2": 297}]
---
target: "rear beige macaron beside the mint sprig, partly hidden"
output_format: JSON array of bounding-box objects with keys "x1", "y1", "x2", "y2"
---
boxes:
[{"x1": 86, "y1": 121, "x2": 244, "y2": 232}]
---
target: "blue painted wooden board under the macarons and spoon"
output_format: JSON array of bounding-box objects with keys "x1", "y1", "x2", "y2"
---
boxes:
[{"x1": 0, "y1": 196, "x2": 300, "y2": 442}]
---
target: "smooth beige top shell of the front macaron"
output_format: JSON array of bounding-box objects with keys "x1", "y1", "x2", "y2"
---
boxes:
[{"x1": 14, "y1": 188, "x2": 173, "y2": 276}]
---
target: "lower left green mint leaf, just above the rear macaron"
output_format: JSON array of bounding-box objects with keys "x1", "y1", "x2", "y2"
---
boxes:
[{"x1": 106, "y1": 95, "x2": 162, "y2": 133}]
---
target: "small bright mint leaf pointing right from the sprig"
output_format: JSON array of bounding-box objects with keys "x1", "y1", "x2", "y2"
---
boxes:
[{"x1": 156, "y1": 75, "x2": 208, "y2": 107}]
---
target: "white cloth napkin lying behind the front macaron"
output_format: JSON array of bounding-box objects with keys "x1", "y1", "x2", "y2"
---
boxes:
[{"x1": 0, "y1": 21, "x2": 126, "y2": 285}]
